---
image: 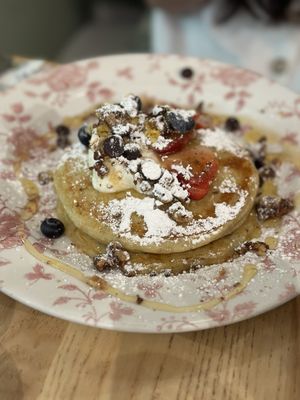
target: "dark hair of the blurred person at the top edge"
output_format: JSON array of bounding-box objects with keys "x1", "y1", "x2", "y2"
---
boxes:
[{"x1": 216, "y1": 0, "x2": 300, "y2": 23}]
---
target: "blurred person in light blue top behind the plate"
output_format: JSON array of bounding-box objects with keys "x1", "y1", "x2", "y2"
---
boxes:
[{"x1": 146, "y1": 0, "x2": 300, "y2": 92}]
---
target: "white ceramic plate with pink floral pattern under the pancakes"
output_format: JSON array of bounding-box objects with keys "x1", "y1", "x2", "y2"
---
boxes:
[{"x1": 0, "y1": 55, "x2": 300, "y2": 332}]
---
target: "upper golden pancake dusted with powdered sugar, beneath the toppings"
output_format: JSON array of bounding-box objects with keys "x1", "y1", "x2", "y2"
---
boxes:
[{"x1": 54, "y1": 141, "x2": 258, "y2": 253}]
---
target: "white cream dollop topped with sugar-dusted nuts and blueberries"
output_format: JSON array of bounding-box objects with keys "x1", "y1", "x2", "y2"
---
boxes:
[{"x1": 88, "y1": 95, "x2": 195, "y2": 203}]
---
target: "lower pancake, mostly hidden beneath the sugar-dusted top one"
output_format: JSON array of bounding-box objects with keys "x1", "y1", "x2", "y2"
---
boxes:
[{"x1": 57, "y1": 198, "x2": 260, "y2": 274}]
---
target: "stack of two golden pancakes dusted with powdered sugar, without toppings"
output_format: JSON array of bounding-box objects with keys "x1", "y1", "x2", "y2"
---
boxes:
[{"x1": 54, "y1": 100, "x2": 259, "y2": 274}]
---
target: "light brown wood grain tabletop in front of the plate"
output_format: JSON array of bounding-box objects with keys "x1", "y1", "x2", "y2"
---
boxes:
[{"x1": 0, "y1": 294, "x2": 300, "y2": 400}]
